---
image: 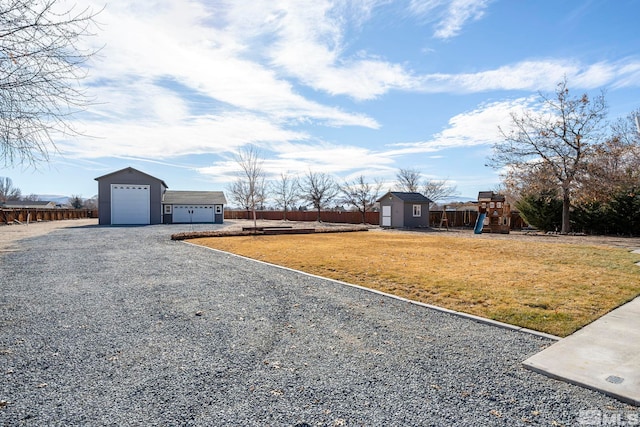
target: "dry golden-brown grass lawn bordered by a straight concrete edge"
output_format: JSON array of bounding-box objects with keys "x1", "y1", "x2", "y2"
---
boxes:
[{"x1": 191, "y1": 231, "x2": 640, "y2": 336}]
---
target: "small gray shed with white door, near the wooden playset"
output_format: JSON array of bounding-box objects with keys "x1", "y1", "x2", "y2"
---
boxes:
[{"x1": 378, "y1": 191, "x2": 431, "y2": 228}]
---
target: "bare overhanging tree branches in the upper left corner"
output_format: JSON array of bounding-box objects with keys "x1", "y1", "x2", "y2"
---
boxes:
[{"x1": 0, "y1": 0, "x2": 95, "y2": 165}]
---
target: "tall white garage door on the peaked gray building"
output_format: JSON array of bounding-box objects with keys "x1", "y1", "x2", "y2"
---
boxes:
[{"x1": 111, "y1": 184, "x2": 151, "y2": 224}]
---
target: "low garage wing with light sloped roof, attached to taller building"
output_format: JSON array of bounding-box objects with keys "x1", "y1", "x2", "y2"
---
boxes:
[{"x1": 162, "y1": 191, "x2": 227, "y2": 224}]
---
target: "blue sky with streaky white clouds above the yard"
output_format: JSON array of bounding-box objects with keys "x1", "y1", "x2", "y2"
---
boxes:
[{"x1": 0, "y1": 0, "x2": 640, "y2": 203}]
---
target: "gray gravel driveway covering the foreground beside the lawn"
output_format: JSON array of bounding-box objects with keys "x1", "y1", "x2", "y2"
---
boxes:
[{"x1": 0, "y1": 225, "x2": 637, "y2": 427}]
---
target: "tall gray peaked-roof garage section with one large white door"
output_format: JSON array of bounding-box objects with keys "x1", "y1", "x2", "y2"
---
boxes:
[{"x1": 96, "y1": 167, "x2": 168, "y2": 225}]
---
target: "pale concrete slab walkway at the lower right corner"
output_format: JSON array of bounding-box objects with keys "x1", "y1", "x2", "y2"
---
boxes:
[{"x1": 523, "y1": 297, "x2": 640, "y2": 406}]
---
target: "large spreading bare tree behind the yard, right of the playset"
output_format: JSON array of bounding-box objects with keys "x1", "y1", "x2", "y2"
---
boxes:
[{"x1": 490, "y1": 79, "x2": 607, "y2": 233}]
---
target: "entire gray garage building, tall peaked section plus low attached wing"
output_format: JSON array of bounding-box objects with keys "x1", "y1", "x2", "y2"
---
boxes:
[{"x1": 96, "y1": 167, "x2": 226, "y2": 225}]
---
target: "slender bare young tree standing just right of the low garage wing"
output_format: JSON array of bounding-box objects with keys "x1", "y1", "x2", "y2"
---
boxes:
[{"x1": 231, "y1": 145, "x2": 267, "y2": 227}]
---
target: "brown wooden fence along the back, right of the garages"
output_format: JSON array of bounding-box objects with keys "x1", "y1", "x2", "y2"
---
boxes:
[{"x1": 224, "y1": 210, "x2": 527, "y2": 230}]
